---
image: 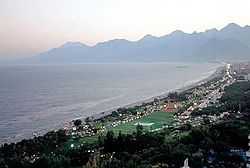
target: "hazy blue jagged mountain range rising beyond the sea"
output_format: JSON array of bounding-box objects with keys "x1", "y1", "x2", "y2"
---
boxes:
[{"x1": 23, "y1": 23, "x2": 250, "y2": 63}]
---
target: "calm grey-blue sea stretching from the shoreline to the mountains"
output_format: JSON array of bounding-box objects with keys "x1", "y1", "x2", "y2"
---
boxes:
[{"x1": 0, "y1": 63, "x2": 218, "y2": 143}]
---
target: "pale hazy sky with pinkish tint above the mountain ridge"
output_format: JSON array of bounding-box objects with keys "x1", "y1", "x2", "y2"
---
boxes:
[{"x1": 0, "y1": 0, "x2": 250, "y2": 58}]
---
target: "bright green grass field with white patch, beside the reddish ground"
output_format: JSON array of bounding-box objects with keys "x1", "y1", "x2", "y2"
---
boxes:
[{"x1": 110, "y1": 112, "x2": 174, "y2": 134}]
